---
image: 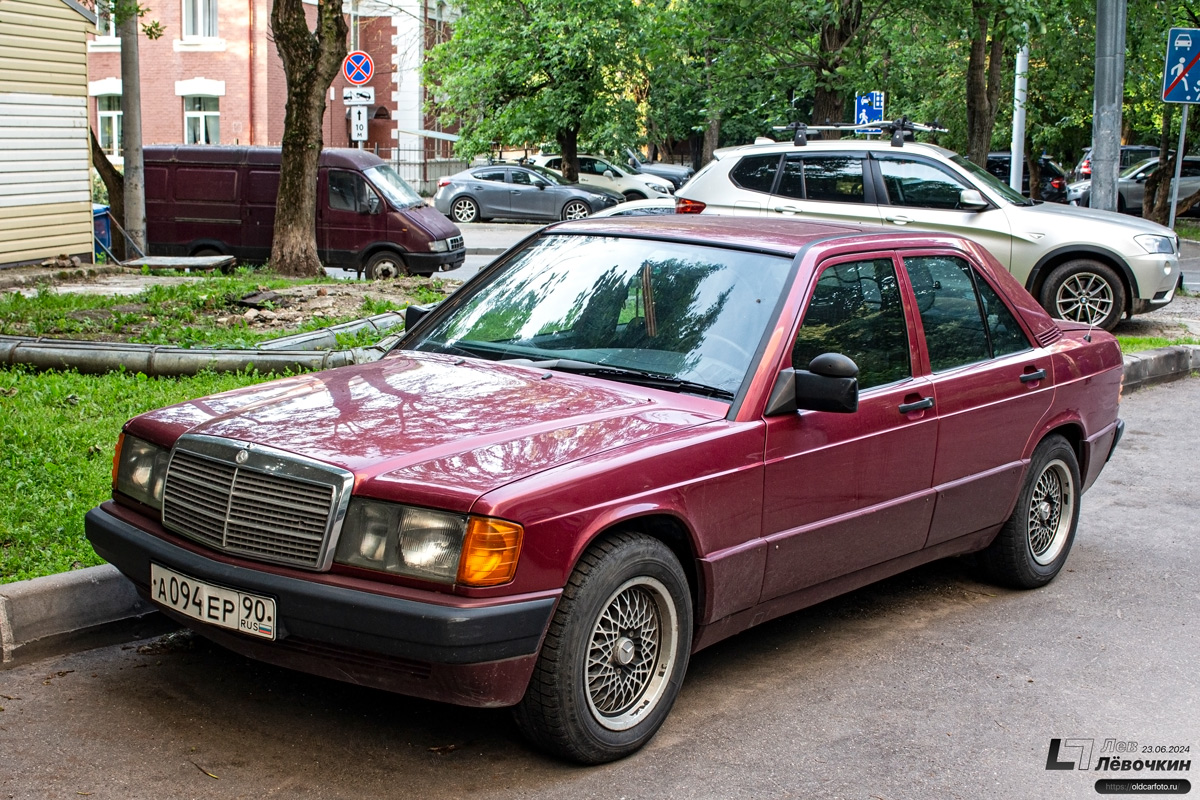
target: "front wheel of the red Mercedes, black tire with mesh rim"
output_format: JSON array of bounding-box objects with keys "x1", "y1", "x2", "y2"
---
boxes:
[{"x1": 514, "y1": 533, "x2": 692, "y2": 764}]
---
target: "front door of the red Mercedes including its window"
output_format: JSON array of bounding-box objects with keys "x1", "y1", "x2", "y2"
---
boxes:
[{"x1": 762, "y1": 254, "x2": 937, "y2": 601}]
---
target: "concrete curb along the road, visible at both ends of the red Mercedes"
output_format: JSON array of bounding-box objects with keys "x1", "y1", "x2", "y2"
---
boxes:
[{"x1": 0, "y1": 344, "x2": 1200, "y2": 668}]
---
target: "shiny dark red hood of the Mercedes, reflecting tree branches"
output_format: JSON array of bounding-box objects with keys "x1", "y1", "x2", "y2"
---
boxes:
[{"x1": 126, "y1": 351, "x2": 727, "y2": 511}]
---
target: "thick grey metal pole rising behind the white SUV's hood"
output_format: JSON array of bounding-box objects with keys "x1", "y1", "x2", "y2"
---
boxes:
[{"x1": 1092, "y1": 0, "x2": 1126, "y2": 211}]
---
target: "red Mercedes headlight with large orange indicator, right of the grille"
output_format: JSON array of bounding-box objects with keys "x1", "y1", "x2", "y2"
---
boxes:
[{"x1": 334, "y1": 498, "x2": 522, "y2": 587}]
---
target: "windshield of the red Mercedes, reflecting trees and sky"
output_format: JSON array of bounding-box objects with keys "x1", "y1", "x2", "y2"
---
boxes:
[{"x1": 404, "y1": 234, "x2": 792, "y2": 399}]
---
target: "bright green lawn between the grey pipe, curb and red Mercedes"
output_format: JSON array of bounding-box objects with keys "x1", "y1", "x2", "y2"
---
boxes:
[{"x1": 0, "y1": 367, "x2": 285, "y2": 583}]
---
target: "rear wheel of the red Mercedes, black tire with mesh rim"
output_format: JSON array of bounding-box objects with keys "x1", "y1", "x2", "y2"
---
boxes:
[{"x1": 979, "y1": 434, "x2": 1080, "y2": 589}]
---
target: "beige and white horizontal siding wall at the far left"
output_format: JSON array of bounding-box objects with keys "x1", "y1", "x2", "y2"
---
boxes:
[{"x1": 0, "y1": 0, "x2": 92, "y2": 265}]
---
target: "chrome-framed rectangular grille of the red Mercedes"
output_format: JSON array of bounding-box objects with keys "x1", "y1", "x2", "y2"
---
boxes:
[{"x1": 162, "y1": 437, "x2": 353, "y2": 570}]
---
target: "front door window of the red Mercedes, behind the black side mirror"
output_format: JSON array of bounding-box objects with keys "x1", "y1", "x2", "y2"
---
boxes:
[{"x1": 792, "y1": 258, "x2": 912, "y2": 389}]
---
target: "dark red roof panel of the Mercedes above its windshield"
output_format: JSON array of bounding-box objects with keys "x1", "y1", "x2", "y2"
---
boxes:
[{"x1": 546, "y1": 215, "x2": 964, "y2": 255}]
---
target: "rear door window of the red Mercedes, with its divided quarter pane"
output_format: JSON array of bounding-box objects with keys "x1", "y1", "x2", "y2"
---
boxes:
[{"x1": 905, "y1": 255, "x2": 1030, "y2": 372}]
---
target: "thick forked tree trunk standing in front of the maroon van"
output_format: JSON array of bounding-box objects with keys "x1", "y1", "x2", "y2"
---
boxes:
[{"x1": 271, "y1": 0, "x2": 348, "y2": 277}]
